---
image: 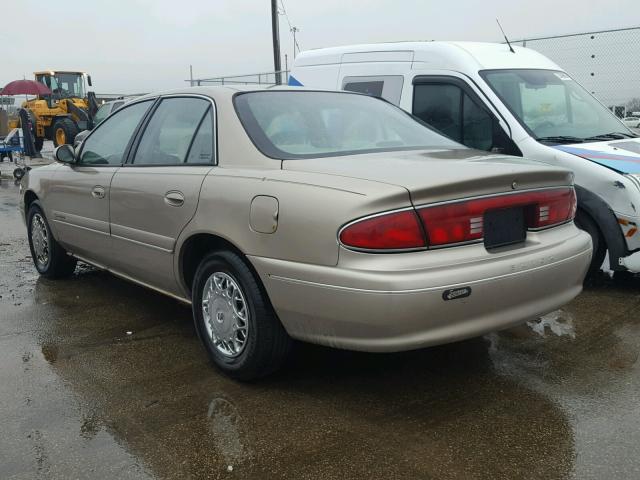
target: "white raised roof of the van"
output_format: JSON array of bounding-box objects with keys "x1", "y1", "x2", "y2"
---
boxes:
[{"x1": 294, "y1": 41, "x2": 562, "y2": 70}]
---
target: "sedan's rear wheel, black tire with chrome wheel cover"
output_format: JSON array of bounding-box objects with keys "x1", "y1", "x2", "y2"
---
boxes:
[{"x1": 192, "y1": 251, "x2": 292, "y2": 381}]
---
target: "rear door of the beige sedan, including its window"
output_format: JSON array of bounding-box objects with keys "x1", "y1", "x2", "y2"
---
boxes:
[{"x1": 105, "y1": 96, "x2": 215, "y2": 293}]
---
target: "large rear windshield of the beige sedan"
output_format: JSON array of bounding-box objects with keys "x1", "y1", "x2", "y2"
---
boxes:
[{"x1": 234, "y1": 91, "x2": 461, "y2": 159}]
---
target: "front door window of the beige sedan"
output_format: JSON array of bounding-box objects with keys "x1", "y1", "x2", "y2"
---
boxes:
[{"x1": 79, "y1": 100, "x2": 153, "y2": 165}]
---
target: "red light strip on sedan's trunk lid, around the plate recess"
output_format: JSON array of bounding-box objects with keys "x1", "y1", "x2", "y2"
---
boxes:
[{"x1": 418, "y1": 188, "x2": 576, "y2": 246}]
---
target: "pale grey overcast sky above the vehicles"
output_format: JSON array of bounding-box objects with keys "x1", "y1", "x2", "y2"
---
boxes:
[{"x1": 0, "y1": 0, "x2": 640, "y2": 93}]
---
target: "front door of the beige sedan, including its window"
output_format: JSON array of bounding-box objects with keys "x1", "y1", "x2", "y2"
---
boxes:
[{"x1": 46, "y1": 100, "x2": 153, "y2": 266}]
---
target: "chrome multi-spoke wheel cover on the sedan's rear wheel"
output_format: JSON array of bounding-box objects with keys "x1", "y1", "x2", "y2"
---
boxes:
[{"x1": 202, "y1": 272, "x2": 249, "y2": 358}]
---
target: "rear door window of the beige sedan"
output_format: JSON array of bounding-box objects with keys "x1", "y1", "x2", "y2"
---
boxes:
[{"x1": 133, "y1": 97, "x2": 213, "y2": 165}]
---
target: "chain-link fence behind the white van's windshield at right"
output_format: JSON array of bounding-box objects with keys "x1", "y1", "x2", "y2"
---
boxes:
[{"x1": 511, "y1": 27, "x2": 640, "y2": 117}]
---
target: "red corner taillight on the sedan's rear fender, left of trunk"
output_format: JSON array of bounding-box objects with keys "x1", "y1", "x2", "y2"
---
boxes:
[{"x1": 340, "y1": 210, "x2": 426, "y2": 250}]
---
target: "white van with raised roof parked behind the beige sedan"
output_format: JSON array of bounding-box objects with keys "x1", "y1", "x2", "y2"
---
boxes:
[{"x1": 289, "y1": 42, "x2": 640, "y2": 272}]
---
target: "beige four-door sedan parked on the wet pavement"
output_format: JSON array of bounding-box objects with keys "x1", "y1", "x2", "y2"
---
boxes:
[{"x1": 22, "y1": 87, "x2": 591, "y2": 379}]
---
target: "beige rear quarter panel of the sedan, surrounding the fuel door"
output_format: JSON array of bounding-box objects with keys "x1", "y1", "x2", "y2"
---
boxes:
[{"x1": 178, "y1": 168, "x2": 410, "y2": 265}]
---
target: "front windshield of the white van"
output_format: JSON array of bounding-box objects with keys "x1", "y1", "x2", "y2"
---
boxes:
[{"x1": 480, "y1": 69, "x2": 631, "y2": 143}]
